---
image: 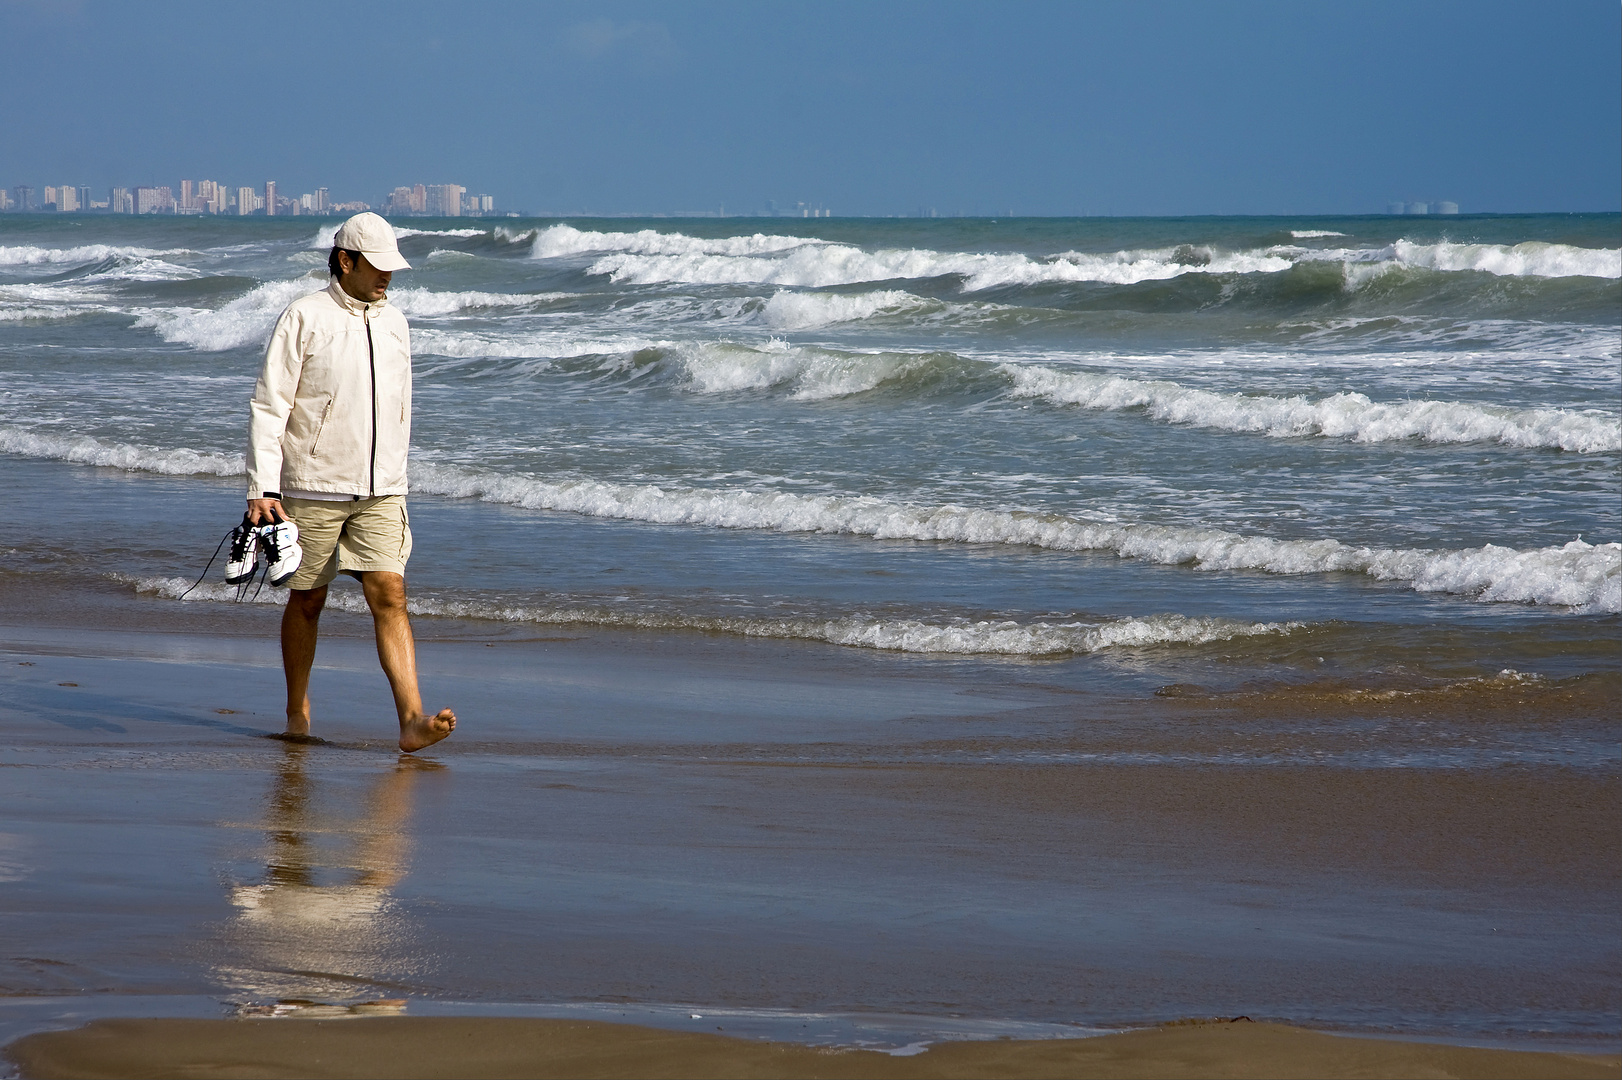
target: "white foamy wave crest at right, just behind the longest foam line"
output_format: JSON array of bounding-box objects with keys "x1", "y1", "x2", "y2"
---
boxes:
[{"x1": 1001, "y1": 363, "x2": 1622, "y2": 454}]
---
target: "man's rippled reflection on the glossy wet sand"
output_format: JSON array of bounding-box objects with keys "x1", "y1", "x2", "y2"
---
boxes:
[{"x1": 216, "y1": 743, "x2": 444, "y2": 1001}]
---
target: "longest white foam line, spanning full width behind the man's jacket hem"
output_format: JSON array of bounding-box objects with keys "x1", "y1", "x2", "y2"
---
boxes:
[{"x1": 9, "y1": 426, "x2": 1622, "y2": 613}]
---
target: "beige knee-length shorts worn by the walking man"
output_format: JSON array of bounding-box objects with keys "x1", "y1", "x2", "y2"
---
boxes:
[{"x1": 282, "y1": 495, "x2": 410, "y2": 589}]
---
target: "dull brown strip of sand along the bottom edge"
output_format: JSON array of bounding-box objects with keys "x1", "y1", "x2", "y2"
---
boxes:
[{"x1": 6, "y1": 1018, "x2": 1622, "y2": 1080}]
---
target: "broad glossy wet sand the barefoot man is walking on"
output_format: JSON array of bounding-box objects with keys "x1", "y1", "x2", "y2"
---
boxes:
[{"x1": 0, "y1": 579, "x2": 1622, "y2": 1050}]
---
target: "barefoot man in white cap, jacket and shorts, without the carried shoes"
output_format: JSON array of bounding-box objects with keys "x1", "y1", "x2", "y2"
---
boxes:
[{"x1": 248, "y1": 214, "x2": 456, "y2": 752}]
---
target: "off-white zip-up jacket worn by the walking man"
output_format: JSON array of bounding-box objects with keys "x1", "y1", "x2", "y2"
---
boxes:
[{"x1": 248, "y1": 279, "x2": 410, "y2": 499}]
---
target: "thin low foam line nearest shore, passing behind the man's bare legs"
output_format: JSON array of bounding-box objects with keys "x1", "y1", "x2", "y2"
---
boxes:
[{"x1": 118, "y1": 577, "x2": 1302, "y2": 657}]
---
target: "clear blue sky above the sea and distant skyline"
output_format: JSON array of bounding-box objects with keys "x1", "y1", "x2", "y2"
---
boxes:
[{"x1": 0, "y1": 0, "x2": 1622, "y2": 214}]
